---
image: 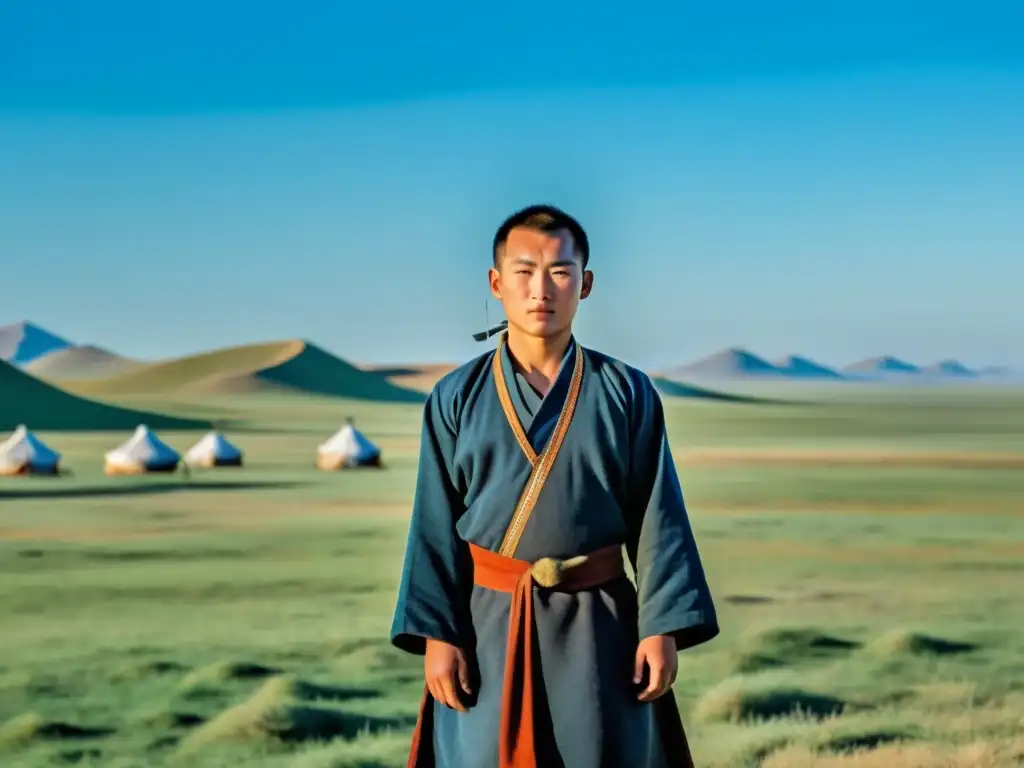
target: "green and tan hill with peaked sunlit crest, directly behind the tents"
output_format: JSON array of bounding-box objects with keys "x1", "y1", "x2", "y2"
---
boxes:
[{"x1": 65, "y1": 340, "x2": 425, "y2": 402}]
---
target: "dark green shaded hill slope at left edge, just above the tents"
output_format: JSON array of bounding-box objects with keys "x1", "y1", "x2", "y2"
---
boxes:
[{"x1": 0, "y1": 361, "x2": 211, "y2": 431}]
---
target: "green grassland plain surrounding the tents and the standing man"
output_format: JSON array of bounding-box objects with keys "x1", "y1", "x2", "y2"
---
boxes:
[{"x1": 0, "y1": 387, "x2": 1024, "y2": 768}]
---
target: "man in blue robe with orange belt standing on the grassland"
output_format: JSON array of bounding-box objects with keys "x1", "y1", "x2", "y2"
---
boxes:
[{"x1": 391, "y1": 206, "x2": 719, "y2": 768}]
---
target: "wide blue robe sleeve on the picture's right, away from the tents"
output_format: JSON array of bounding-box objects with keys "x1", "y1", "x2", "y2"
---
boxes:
[{"x1": 627, "y1": 374, "x2": 719, "y2": 650}]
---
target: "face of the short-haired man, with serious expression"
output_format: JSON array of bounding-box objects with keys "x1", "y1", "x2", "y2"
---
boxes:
[{"x1": 488, "y1": 228, "x2": 594, "y2": 338}]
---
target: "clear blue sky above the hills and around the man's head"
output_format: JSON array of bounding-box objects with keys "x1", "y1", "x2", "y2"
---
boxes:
[{"x1": 0, "y1": 0, "x2": 1024, "y2": 368}]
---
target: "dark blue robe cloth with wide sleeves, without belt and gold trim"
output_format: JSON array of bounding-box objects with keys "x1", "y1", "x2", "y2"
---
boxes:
[{"x1": 391, "y1": 339, "x2": 719, "y2": 768}]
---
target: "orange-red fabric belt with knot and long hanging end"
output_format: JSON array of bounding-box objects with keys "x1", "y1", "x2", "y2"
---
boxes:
[{"x1": 469, "y1": 544, "x2": 626, "y2": 768}]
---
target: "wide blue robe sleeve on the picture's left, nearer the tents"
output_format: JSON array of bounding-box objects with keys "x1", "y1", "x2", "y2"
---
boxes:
[{"x1": 391, "y1": 382, "x2": 472, "y2": 655}]
